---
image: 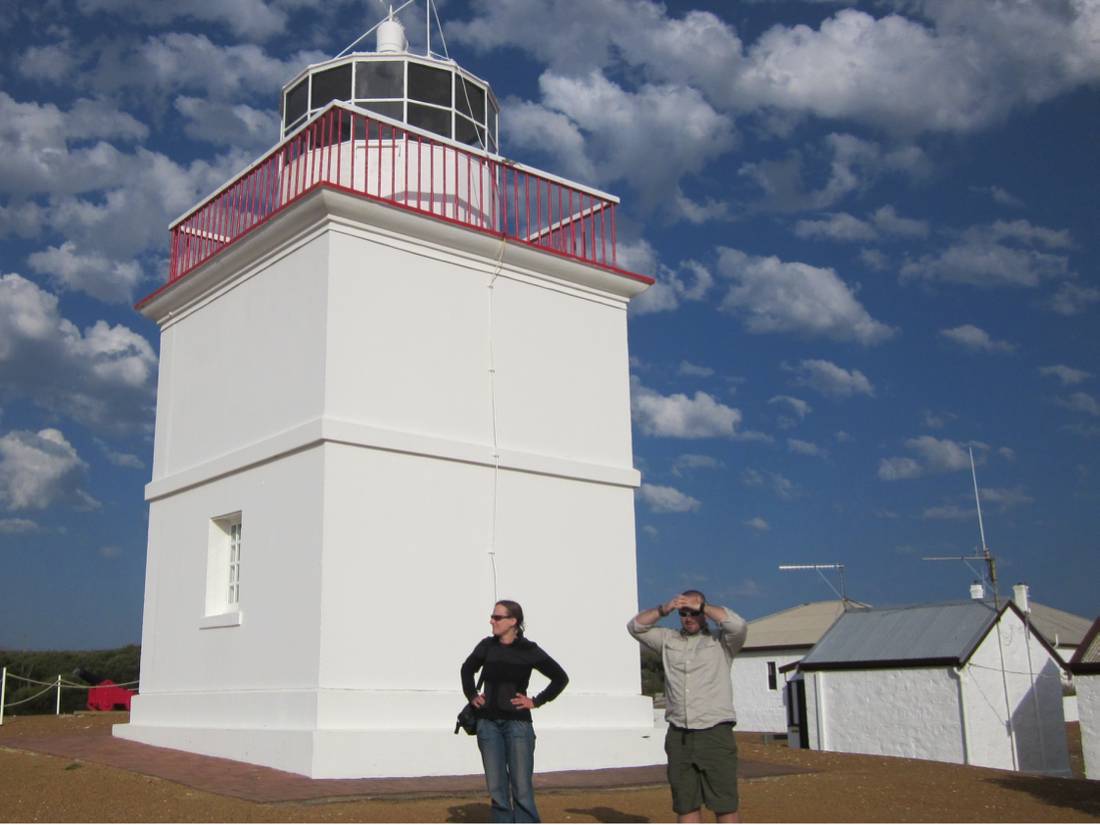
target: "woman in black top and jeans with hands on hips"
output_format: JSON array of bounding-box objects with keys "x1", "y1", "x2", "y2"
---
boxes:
[{"x1": 462, "y1": 601, "x2": 569, "y2": 822}]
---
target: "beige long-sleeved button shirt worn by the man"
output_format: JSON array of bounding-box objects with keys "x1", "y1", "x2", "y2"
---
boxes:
[{"x1": 627, "y1": 607, "x2": 748, "y2": 730}]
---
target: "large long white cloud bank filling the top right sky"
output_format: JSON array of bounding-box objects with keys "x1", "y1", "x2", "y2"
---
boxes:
[{"x1": 448, "y1": 0, "x2": 1100, "y2": 133}]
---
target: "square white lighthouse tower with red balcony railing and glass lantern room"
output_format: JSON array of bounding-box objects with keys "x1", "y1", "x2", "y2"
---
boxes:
[{"x1": 116, "y1": 8, "x2": 662, "y2": 777}]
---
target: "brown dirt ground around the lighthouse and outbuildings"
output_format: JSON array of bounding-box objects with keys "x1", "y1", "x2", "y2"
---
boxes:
[{"x1": 0, "y1": 714, "x2": 1100, "y2": 823}]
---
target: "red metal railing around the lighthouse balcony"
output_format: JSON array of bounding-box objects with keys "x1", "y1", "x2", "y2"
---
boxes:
[{"x1": 168, "y1": 102, "x2": 649, "y2": 283}]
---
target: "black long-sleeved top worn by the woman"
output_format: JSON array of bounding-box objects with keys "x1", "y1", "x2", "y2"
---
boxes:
[{"x1": 462, "y1": 636, "x2": 569, "y2": 722}]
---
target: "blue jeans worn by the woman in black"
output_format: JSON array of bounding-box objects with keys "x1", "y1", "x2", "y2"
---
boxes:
[{"x1": 477, "y1": 719, "x2": 541, "y2": 822}]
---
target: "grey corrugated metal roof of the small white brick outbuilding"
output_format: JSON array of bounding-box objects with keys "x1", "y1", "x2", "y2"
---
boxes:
[{"x1": 800, "y1": 600, "x2": 997, "y2": 670}]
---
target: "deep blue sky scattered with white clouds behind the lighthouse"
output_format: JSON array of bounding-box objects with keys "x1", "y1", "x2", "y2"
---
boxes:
[{"x1": 0, "y1": 0, "x2": 1100, "y2": 648}]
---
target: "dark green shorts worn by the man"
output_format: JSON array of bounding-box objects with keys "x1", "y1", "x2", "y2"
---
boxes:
[{"x1": 664, "y1": 722, "x2": 738, "y2": 814}]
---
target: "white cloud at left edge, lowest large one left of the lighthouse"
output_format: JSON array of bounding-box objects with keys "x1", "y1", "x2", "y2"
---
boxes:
[{"x1": 0, "y1": 429, "x2": 99, "y2": 510}]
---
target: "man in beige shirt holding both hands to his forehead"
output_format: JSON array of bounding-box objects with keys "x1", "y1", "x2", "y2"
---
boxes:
[{"x1": 627, "y1": 590, "x2": 748, "y2": 822}]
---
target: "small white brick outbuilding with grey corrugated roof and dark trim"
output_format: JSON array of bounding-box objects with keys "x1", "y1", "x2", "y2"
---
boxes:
[{"x1": 799, "y1": 600, "x2": 1069, "y2": 776}]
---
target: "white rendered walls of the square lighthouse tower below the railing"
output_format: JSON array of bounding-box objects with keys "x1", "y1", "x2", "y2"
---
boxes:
[{"x1": 117, "y1": 193, "x2": 661, "y2": 777}]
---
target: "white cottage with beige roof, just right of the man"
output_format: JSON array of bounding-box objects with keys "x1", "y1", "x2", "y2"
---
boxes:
[{"x1": 730, "y1": 598, "x2": 866, "y2": 734}]
